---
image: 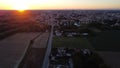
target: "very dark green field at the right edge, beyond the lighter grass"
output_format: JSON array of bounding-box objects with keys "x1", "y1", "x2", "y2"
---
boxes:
[{"x1": 89, "y1": 30, "x2": 120, "y2": 51}]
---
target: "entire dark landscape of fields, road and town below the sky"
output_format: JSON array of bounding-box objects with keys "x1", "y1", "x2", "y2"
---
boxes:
[{"x1": 0, "y1": 10, "x2": 120, "y2": 68}]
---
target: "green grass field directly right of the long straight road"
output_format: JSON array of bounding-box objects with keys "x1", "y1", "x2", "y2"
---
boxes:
[{"x1": 52, "y1": 37, "x2": 93, "y2": 49}]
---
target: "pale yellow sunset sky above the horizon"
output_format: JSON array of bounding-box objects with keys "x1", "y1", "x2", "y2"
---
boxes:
[{"x1": 0, "y1": 0, "x2": 120, "y2": 10}]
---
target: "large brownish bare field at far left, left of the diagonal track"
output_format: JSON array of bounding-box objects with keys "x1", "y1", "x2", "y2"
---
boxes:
[{"x1": 0, "y1": 32, "x2": 40, "y2": 68}]
